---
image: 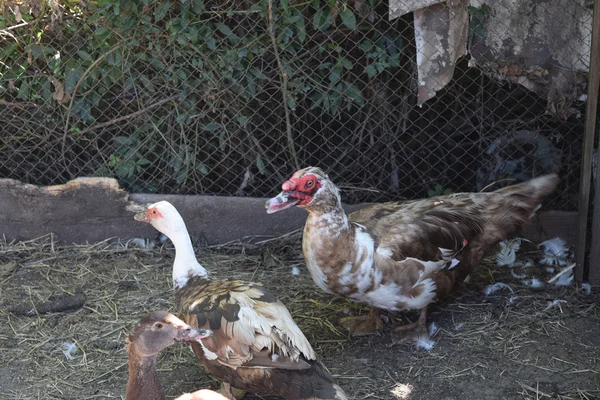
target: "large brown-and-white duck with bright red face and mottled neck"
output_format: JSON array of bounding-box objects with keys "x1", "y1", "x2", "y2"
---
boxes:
[{"x1": 267, "y1": 167, "x2": 558, "y2": 335}]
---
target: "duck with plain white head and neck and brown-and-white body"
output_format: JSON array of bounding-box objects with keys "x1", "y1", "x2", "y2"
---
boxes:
[{"x1": 136, "y1": 201, "x2": 346, "y2": 399}]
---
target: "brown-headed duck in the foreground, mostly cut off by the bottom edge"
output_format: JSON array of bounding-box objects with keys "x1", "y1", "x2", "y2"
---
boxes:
[{"x1": 125, "y1": 311, "x2": 221, "y2": 400}]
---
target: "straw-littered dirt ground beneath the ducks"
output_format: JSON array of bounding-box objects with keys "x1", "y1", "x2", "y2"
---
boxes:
[{"x1": 0, "y1": 236, "x2": 600, "y2": 400}]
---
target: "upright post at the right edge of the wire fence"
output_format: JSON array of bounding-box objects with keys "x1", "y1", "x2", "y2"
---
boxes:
[{"x1": 575, "y1": 0, "x2": 600, "y2": 284}]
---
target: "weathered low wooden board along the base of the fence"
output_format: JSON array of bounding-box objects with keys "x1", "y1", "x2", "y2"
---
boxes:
[{"x1": 0, "y1": 178, "x2": 576, "y2": 244}]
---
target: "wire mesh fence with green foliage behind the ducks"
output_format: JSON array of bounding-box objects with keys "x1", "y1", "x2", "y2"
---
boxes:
[{"x1": 0, "y1": 0, "x2": 592, "y2": 210}]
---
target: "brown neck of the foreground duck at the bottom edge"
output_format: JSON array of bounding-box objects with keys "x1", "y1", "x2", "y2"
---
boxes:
[{"x1": 125, "y1": 345, "x2": 165, "y2": 400}]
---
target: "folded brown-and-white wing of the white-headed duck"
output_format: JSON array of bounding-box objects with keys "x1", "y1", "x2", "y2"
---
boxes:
[{"x1": 175, "y1": 277, "x2": 316, "y2": 369}]
